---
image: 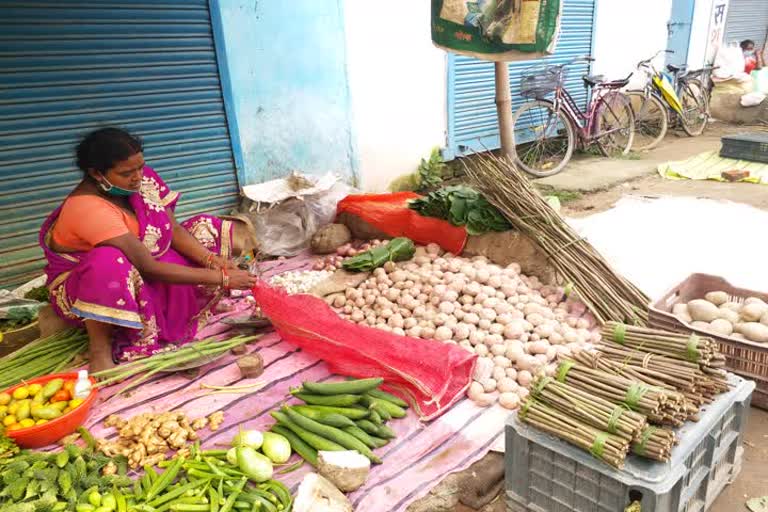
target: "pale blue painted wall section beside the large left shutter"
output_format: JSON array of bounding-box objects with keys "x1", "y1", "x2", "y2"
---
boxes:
[{"x1": 212, "y1": 0, "x2": 356, "y2": 185}]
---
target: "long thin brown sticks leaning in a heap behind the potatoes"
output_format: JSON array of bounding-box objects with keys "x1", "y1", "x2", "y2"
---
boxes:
[{"x1": 462, "y1": 153, "x2": 650, "y2": 325}]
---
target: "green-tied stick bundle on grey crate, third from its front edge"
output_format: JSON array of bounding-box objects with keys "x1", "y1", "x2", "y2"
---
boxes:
[{"x1": 557, "y1": 352, "x2": 690, "y2": 426}]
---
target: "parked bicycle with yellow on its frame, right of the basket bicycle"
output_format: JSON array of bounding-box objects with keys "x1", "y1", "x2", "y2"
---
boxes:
[{"x1": 626, "y1": 50, "x2": 714, "y2": 151}]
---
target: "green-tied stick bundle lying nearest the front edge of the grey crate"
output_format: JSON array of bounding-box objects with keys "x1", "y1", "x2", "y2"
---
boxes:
[{"x1": 519, "y1": 396, "x2": 630, "y2": 469}]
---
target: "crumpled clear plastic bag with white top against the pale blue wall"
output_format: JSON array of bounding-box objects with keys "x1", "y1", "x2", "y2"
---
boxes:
[{"x1": 241, "y1": 174, "x2": 354, "y2": 256}]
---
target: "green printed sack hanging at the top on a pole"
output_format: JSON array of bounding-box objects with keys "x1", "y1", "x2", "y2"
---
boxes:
[{"x1": 432, "y1": 0, "x2": 563, "y2": 61}]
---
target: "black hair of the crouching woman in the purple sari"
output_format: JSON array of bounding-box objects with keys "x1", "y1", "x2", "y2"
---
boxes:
[{"x1": 75, "y1": 127, "x2": 144, "y2": 174}]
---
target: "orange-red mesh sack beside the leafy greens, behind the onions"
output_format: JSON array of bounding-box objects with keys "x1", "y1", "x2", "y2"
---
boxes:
[{"x1": 336, "y1": 192, "x2": 467, "y2": 254}]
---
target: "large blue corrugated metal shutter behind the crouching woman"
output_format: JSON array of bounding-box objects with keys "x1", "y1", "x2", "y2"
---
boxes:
[{"x1": 0, "y1": 0, "x2": 238, "y2": 287}]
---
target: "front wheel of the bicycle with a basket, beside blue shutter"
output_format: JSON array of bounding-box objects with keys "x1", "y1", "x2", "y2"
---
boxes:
[{"x1": 512, "y1": 100, "x2": 576, "y2": 178}]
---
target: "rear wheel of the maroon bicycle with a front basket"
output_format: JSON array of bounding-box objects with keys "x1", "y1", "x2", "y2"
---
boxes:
[{"x1": 593, "y1": 91, "x2": 635, "y2": 158}]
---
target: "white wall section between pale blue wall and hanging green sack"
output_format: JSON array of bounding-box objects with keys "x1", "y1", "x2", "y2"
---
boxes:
[{"x1": 343, "y1": 0, "x2": 447, "y2": 192}]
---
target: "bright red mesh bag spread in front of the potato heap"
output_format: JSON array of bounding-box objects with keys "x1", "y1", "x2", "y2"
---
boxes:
[{"x1": 253, "y1": 281, "x2": 477, "y2": 420}]
